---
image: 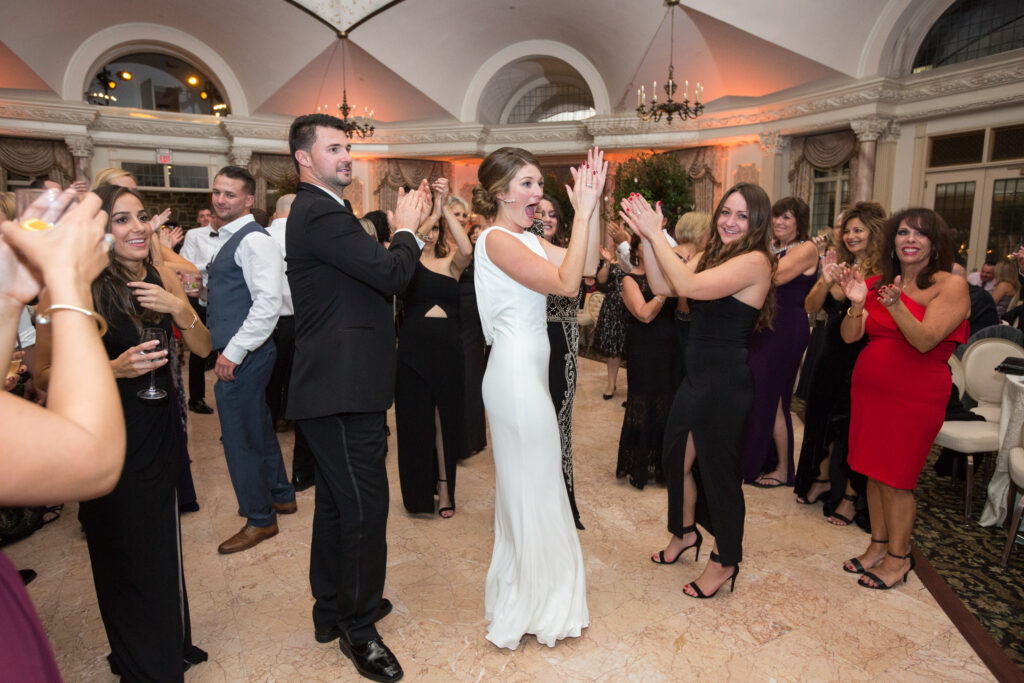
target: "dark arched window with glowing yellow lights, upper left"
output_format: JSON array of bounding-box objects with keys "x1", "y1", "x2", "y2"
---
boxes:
[{"x1": 85, "y1": 52, "x2": 230, "y2": 116}]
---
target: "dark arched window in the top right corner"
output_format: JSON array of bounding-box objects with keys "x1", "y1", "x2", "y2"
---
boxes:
[{"x1": 913, "y1": 0, "x2": 1024, "y2": 74}]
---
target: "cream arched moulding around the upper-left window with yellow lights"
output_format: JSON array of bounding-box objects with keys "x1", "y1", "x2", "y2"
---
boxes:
[{"x1": 60, "y1": 23, "x2": 249, "y2": 117}]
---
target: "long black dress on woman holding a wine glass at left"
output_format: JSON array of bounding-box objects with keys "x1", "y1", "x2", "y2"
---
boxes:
[{"x1": 79, "y1": 268, "x2": 207, "y2": 681}]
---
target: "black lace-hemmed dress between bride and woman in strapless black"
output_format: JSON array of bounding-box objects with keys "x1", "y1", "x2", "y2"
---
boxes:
[{"x1": 615, "y1": 273, "x2": 683, "y2": 488}]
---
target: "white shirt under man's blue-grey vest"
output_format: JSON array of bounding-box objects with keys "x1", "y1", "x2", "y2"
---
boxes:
[{"x1": 210, "y1": 213, "x2": 285, "y2": 364}]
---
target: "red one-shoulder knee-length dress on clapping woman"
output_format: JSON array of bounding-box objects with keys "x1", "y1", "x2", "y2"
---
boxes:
[{"x1": 849, "y1": 276, "x2": 968, "y2": 489}]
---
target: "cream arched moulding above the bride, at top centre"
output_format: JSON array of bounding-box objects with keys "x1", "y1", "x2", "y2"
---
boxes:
[{"x1": 459, "y1": 40, "x2": 611, "y2": 122}]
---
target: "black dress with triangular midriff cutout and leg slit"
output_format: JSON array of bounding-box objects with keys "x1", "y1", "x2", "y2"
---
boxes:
[{"x1": 394, "y1": 263, "x2": 467, "y2": 512}]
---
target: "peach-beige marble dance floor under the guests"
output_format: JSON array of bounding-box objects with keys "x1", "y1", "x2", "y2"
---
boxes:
[{"x1": 4, "y1": 359, "x2": 992, "y2": 683}]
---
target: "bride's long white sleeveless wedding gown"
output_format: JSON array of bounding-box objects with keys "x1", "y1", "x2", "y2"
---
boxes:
[{"x1": 474, "y1": 226, "x2": 590, "y2": 649}]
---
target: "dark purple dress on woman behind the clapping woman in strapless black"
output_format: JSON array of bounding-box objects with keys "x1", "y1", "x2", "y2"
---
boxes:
[{"x1": 742, "y1": 250, "x2": 817, "y2": 486}]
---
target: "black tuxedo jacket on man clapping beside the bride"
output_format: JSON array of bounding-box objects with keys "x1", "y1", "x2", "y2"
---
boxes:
[{"x1": 285, "y1": 182, "x2": 420, "y2": 420}]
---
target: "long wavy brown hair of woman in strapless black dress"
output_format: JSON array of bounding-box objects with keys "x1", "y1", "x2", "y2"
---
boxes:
[{"x1": 696, "y1": 182, "x2": 778, "y2": 330}]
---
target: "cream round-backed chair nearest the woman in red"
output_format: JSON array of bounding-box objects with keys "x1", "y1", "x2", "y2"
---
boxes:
[{"x1": 935, "y1": 337, "x2": 1024, "y2": 523}]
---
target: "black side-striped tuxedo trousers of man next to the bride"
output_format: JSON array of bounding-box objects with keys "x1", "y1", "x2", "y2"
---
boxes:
[{"x1": 298, "y1": 412, "x2": 388, "y2": 644}]
